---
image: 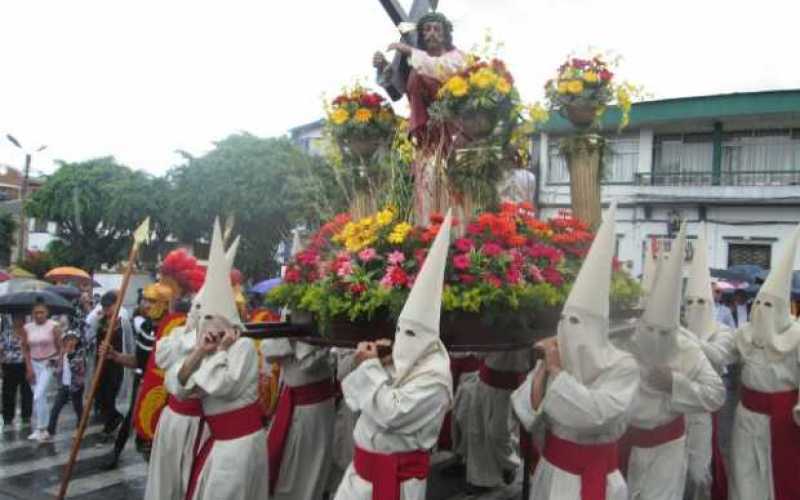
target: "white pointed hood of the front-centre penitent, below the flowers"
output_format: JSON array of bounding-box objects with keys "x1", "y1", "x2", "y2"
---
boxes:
[{"x1": 392, "y1": 210, "x2": 452, "y2": 390}]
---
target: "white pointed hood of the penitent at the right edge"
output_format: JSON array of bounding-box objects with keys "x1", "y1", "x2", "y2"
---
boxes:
[{"x1": 736, "y1": 225, "x2": 800, "y2": 356}]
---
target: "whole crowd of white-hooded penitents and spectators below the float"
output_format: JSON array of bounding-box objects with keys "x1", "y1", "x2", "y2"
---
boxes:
[{"x1": 2, "y1": 208, "x2": 800, "y2": 500}]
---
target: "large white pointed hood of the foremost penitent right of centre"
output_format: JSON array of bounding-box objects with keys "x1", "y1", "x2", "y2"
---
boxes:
[{"x1": 557, "y1": 202, "x2": 624, "y2": 385}]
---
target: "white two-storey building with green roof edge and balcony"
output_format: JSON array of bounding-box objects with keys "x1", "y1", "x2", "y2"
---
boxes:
[{"x1": 534, "y1": 90, "x2": 800, "y2": 275}]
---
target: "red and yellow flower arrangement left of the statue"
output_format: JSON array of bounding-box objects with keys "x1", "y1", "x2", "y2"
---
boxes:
[{"x1": 325, "y1": 85, "x2": 397, "y2": 156}]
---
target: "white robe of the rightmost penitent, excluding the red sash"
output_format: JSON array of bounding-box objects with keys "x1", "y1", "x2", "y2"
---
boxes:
[{"x1": 728, "y1": 342, "x2": 800, "y2": 500}]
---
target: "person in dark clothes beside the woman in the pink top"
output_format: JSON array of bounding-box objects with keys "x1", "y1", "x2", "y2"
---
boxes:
[{"x1": 47, "y1": 330, "x2": 86, "y2": 436}]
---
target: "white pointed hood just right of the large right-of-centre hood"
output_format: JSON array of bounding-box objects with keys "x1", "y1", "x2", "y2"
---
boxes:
[{"x1": 634, "y1": 223, "x2": 686, "y2": 366}]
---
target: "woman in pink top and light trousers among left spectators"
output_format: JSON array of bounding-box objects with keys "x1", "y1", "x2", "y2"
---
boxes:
[{"x1": 23, "y1": 301, "x2": 61, "y2": 442}]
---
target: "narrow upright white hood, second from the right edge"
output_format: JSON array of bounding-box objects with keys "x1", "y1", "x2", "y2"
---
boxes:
[{"x1": 686, "y1": 223, "x2": 719, "y2": 340}]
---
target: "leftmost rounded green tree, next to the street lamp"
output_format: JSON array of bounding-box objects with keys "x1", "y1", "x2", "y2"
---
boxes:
[{"x1": 26, "y1": 157, "x2": 160, "y2": 272}]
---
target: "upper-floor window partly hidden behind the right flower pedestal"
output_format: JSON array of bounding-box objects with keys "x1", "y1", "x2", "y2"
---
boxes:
[{"x1": 547, "y1": 137, "x2": 639, "y2": 184}]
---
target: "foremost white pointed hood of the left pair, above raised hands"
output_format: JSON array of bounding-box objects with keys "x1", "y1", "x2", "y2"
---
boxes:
[{"x1": 197, "y1": 220, "x2": 242, "y2": 328}]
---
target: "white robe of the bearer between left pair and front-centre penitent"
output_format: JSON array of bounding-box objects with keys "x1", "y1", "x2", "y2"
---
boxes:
[{"x1": 261, "y1": 339, "x2": 336, "y2": 500}]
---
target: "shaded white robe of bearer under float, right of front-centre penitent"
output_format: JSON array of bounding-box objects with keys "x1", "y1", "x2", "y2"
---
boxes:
[{"x1": 458, "y1": 350, "x2": 530, "y2": 487}]
